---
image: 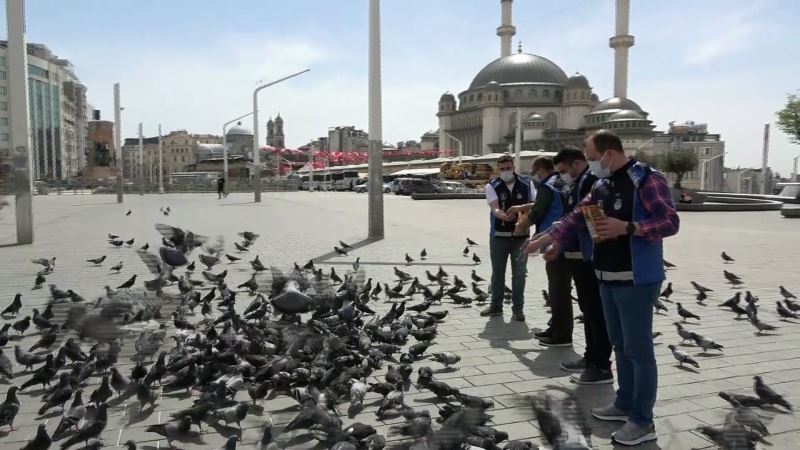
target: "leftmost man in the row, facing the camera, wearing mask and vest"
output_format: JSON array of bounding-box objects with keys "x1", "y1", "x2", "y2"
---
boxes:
[{"x1": 481, "y1": 155, "x2": 533, "y2": 322}]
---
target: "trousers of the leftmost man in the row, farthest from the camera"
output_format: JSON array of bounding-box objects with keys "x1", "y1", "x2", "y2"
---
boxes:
[{"x1": 489, "y1": 237, "x2": 528, "y2": 312}]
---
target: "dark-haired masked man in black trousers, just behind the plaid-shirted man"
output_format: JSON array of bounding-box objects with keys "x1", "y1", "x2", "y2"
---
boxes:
[{"x1": 553, "y1": 147, "x2": 614, "y2": 384}]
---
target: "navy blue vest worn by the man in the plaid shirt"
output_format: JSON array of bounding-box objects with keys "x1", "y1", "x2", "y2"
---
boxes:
[{"x1": 592, "y1": 160, "x2": 666, "y2": 284}]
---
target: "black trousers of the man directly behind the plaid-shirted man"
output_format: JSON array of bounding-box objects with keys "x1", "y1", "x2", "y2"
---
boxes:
[{"x1": 568, "y1": 260, "x2": 611, "y2": 370}]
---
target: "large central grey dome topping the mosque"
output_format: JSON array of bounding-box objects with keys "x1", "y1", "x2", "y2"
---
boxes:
[{"x1": 469, "y1": 53, "x2": 568, "y2": 89}]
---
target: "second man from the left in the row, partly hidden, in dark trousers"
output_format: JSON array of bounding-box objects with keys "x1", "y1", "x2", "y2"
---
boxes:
[{"x1": 511, "y1": 156, "x2": 572, "y2": 340}]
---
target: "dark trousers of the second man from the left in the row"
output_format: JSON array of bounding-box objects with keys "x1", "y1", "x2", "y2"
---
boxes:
[{"x1": 544, "y1": 256, "x2": 573, "y2": 341}]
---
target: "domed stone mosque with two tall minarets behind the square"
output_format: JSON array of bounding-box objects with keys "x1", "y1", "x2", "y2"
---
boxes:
[{"x1": 437, "y1": 0, "x2": 658, "y2": 155}]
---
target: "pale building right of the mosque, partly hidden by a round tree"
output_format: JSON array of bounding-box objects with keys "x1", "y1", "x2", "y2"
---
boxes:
[{"x1": 645, "y1": 121, "x2": 725, "y2": 192}]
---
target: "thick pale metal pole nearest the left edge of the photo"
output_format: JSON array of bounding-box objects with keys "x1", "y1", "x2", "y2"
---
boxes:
[{"x1": 6, "y1": 0, "x2": 33, "y2": 244}]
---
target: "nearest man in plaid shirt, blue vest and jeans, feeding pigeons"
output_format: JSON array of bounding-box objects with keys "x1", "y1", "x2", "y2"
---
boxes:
[{"x1": 526, "y1": 130, "x2": 679, "y2": 445}]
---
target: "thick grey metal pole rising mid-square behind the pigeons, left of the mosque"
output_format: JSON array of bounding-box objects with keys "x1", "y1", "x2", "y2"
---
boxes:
[{"x1": 367, "y1": 0, "x2": 384, "y2": 239}]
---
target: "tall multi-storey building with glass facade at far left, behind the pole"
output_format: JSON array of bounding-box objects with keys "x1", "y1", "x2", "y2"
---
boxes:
[{"x1": 0, "y1": 41, "x2": 88, "y2": 180}]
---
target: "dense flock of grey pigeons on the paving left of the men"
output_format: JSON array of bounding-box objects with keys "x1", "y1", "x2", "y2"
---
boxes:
[{"x1": 0, "y1": 210, "x2": 580, "y2": 450}]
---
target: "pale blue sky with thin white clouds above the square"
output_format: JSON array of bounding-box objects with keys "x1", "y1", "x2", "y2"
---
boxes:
[{"x1": 2, "y1": 0, "x2": 800, "y2": 174}]
